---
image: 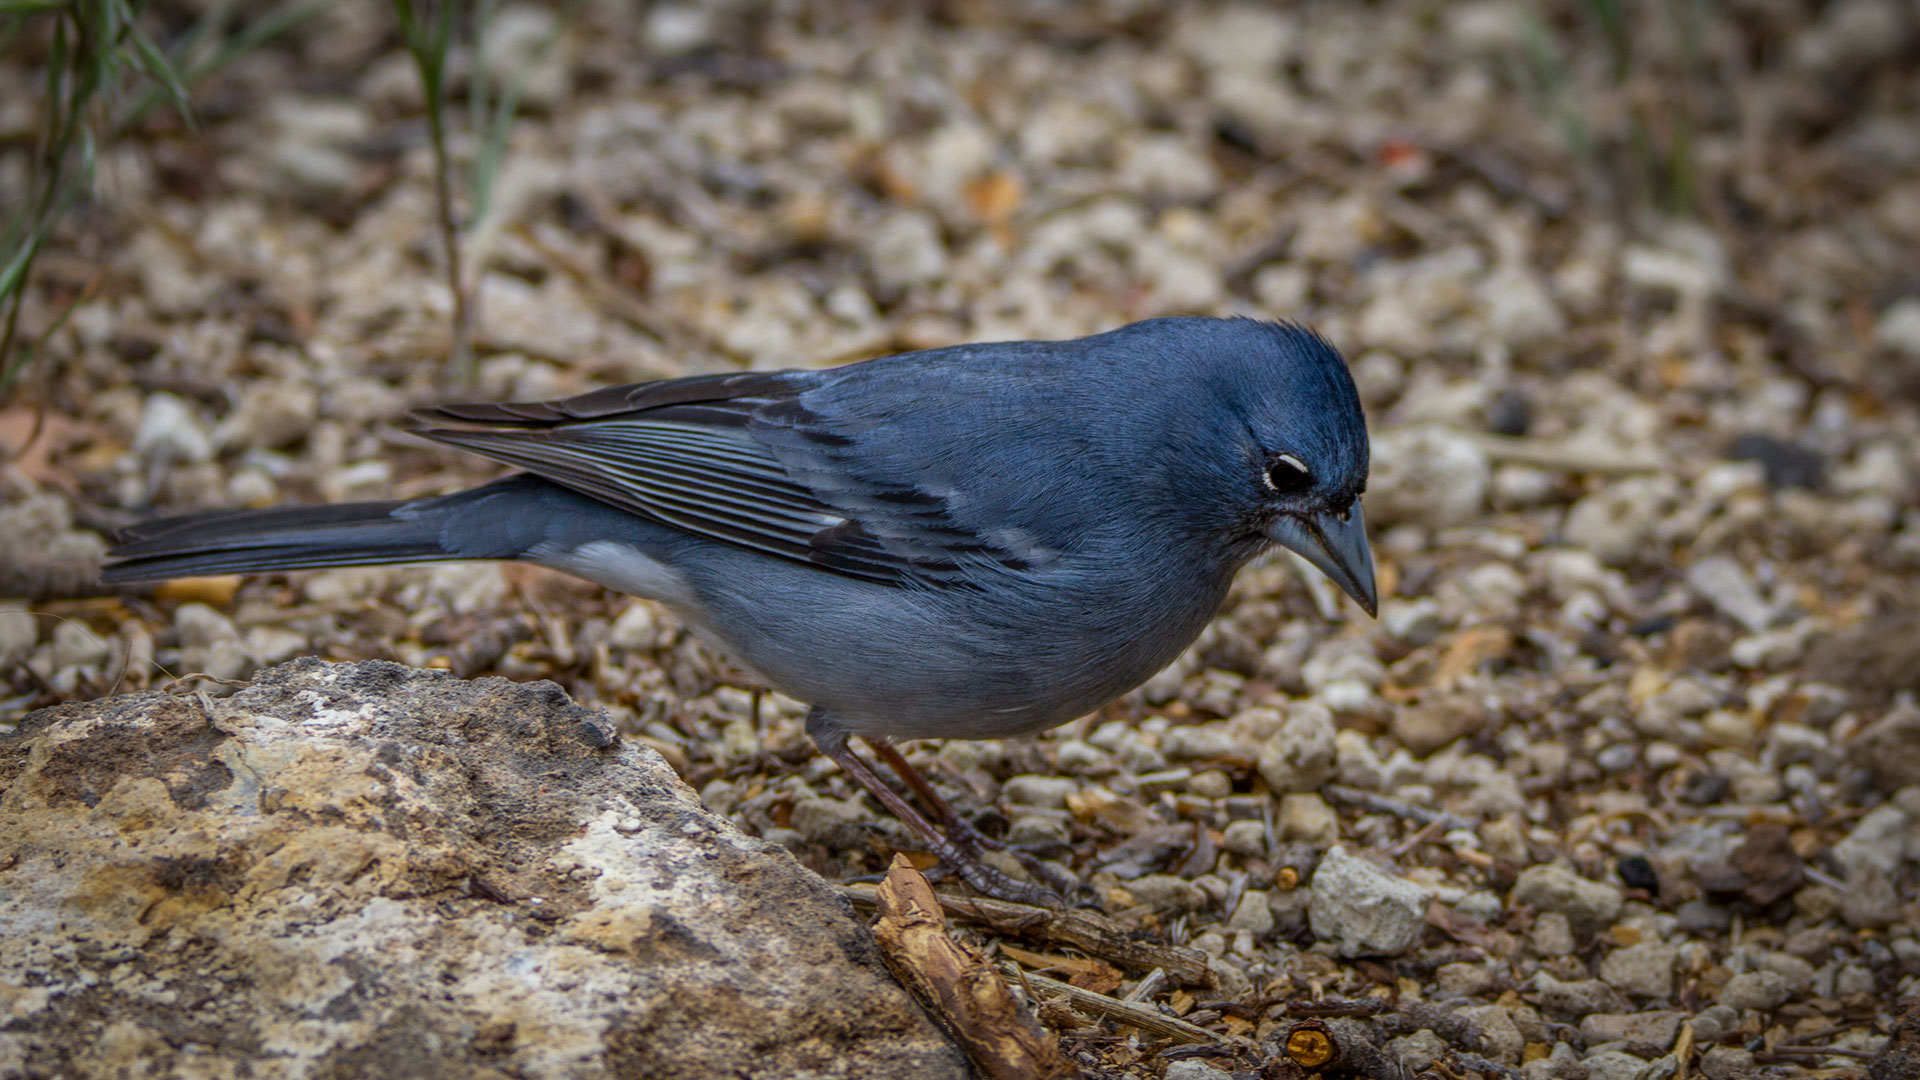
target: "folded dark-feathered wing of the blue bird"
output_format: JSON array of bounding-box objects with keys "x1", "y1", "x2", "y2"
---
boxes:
[{"x1": 411, "y1": 371, "x2": 1020, "y2": 584}]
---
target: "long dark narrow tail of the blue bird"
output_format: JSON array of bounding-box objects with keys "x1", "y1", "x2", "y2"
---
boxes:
[{"x1": 100, "y1": 502, "x2": 449, "y2": 582}]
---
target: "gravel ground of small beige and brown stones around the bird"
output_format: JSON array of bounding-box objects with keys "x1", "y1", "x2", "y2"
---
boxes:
[{"x1": 0, "y1": 0, "x2": 1920, "y2": 1080}]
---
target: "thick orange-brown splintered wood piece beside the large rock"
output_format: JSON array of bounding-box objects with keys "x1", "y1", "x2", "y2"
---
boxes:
[{"x1": 874, "y1": 855, "x2": 1079, "y2": 1080}]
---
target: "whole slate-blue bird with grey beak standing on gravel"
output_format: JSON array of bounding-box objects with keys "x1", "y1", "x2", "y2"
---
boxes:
[{"x1": 104, "y1": 317, "x2": 1377, "y2": 899}]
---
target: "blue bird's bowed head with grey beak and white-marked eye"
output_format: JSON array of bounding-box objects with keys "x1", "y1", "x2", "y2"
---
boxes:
[{"x1": 1175, "y1": 319, "x2": 1379, "y2": 615}]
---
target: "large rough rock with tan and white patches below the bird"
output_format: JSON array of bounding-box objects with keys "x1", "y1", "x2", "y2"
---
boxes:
[{"x1": 0, "y1": 661, "x2": 966, "y2": 1080}]
